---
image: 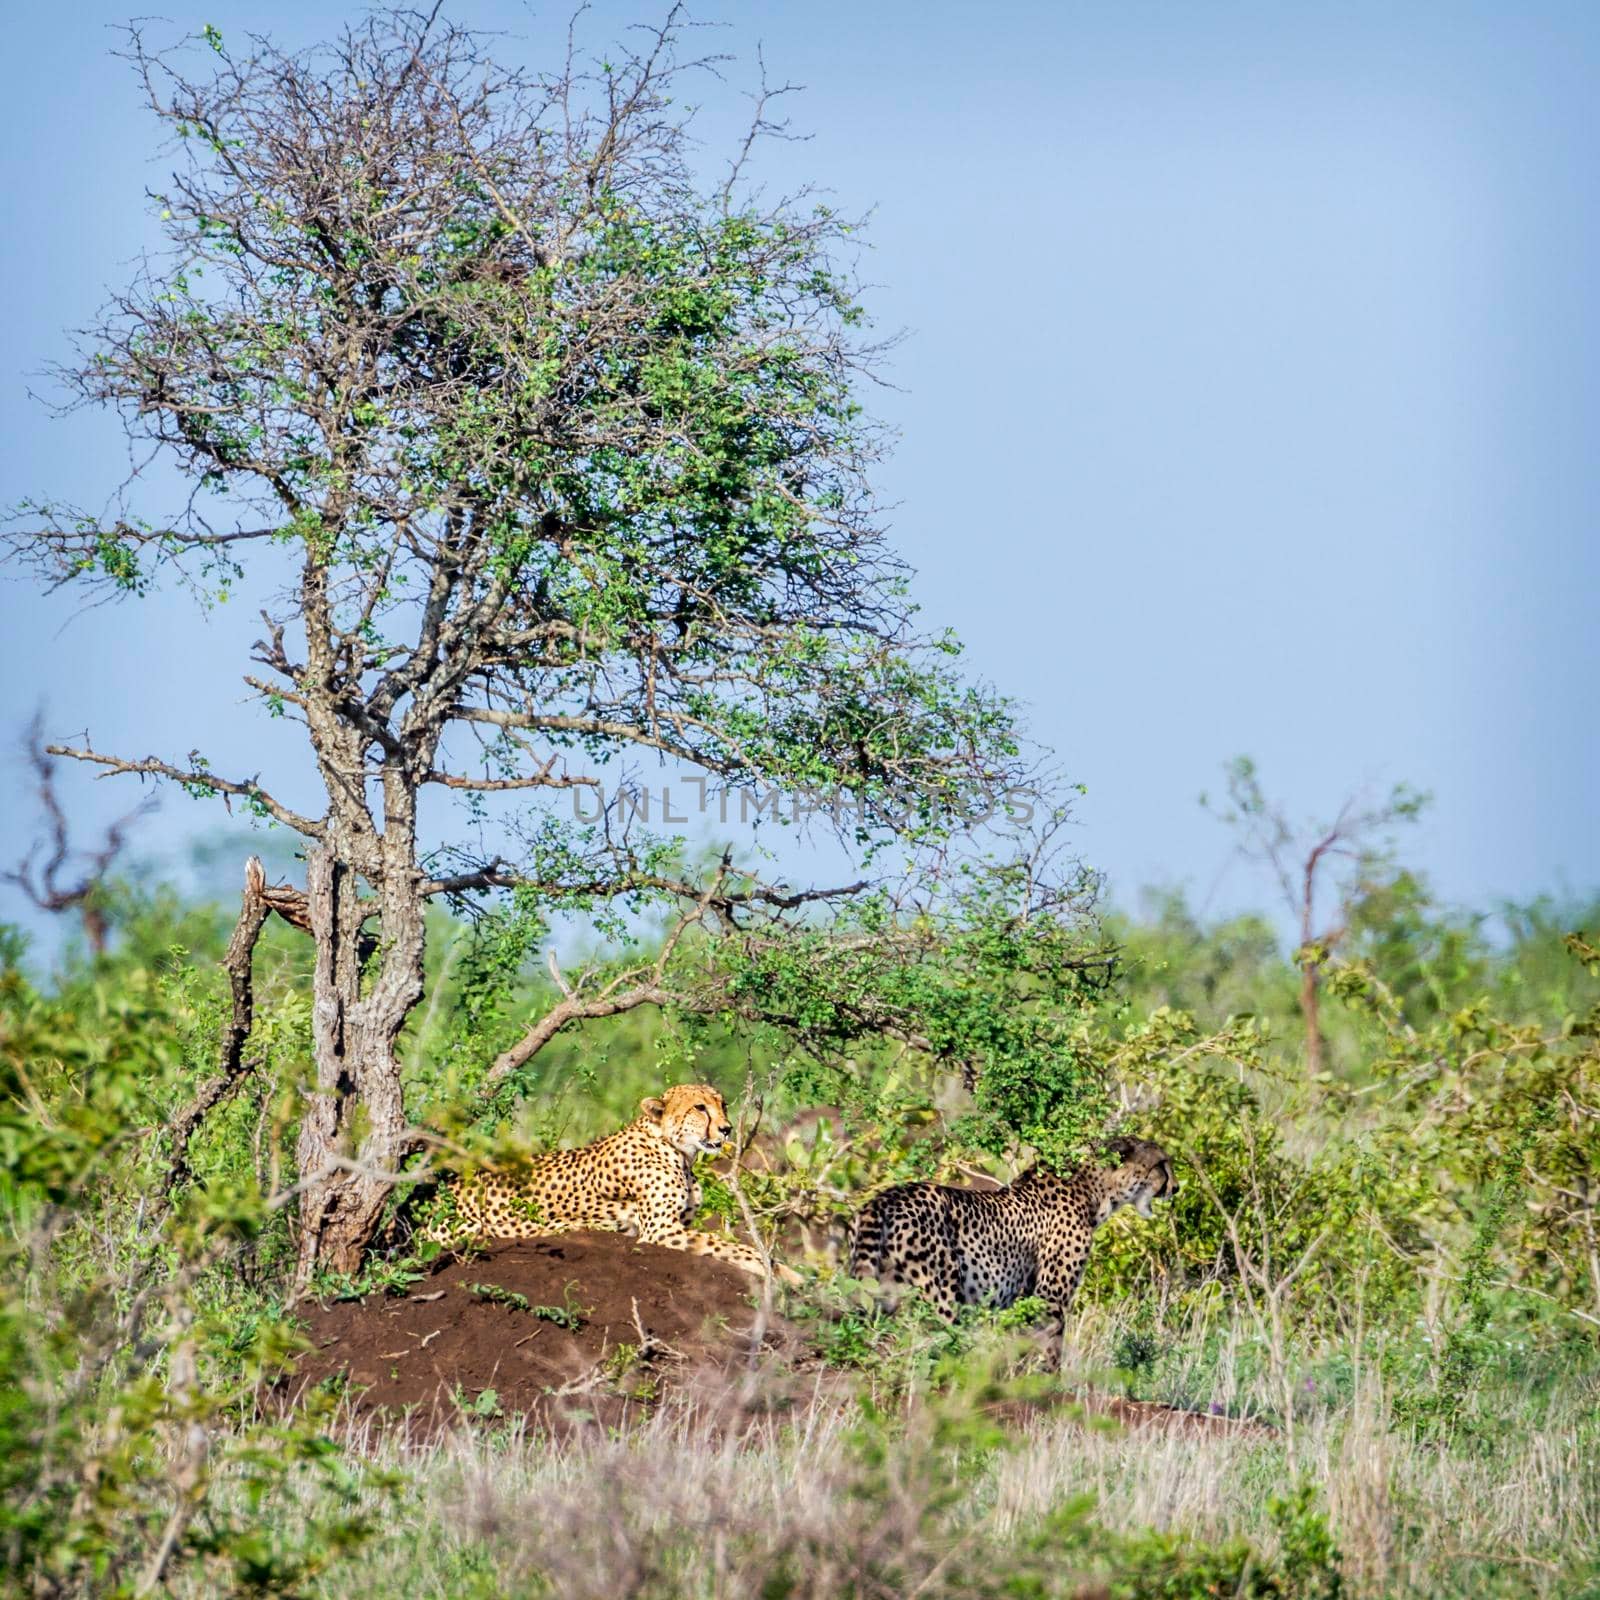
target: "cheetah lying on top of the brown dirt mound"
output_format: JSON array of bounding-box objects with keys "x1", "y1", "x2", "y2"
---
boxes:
[{"x1": 422, "y1": 1083, "x2": 792, "y2": 1277}]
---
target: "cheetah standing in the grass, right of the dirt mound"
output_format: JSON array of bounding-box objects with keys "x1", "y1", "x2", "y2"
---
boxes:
[{"x1": 850, "y1": 1139, "x2": 1178, "y2": 1318}]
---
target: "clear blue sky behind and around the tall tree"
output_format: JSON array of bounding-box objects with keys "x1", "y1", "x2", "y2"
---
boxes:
[{"x1": 0, "y1": 0, "x2": 1600, "y2": 940}]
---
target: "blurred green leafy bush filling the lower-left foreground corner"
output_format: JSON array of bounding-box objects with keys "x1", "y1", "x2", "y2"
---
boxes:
[{"x1": 0, "y1": 928, "x2": 395, "y2": 1594}]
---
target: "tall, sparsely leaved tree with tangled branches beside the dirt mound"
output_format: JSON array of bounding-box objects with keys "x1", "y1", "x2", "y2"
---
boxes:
[{"x1": 10, "y1": 8, "x2": 1088, "y2": 1275}]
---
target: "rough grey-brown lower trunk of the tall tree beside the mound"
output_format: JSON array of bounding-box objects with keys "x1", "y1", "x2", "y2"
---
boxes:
[{"x1": 294, "y1": 827, "x2": 422, "y2": 1288}]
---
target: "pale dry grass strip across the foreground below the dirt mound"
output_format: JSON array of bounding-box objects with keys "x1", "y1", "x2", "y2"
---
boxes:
[{"x1": 175, "y1": 1322, "x2": 1600, "y2": 1600}]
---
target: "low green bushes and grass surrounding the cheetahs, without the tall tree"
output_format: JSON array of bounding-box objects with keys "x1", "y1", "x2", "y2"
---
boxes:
[{"x1": 0, "y1": 832, "x2": 1600, "y2": 1597}]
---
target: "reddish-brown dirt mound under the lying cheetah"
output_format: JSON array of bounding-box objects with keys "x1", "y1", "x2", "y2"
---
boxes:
[{"x1": 286, "y1": 1234, "x2": 787, "y2": 1427}]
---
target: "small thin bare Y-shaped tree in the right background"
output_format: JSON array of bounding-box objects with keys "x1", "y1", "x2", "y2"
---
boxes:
[{"x1": 1200, "y1": 755, "x2": 1427, "y2": 1078}]
